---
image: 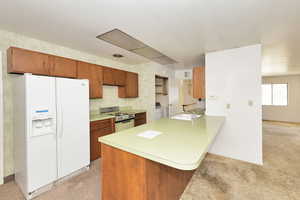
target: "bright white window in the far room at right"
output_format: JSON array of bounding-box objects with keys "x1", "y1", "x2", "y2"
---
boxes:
[{"x1": 262, "y1": 84, "x2": 288, "y2": 106}]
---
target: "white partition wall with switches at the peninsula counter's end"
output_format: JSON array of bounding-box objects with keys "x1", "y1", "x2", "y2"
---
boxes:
[{"x1": 205, "y1": 45, "x2": 262, "y2": 164}]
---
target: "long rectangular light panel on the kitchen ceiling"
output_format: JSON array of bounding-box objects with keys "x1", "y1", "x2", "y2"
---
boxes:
[{"x1": 97, "y1": 29, "x2": 176, "y2": 65}]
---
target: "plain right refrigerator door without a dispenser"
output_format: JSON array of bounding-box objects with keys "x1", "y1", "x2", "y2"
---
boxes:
[{"x1": 56, "y1": 78, "x2": 90, "y2": 178}]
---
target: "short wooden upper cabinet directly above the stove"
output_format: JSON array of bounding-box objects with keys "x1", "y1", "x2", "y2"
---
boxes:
[{"x1": 103, "y1": 67, "x2": 126, "y2": 86}]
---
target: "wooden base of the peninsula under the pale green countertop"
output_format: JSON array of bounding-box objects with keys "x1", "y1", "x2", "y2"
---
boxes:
[{"x1": 100, "y1": 144, "x2": 194, "y2": 200}]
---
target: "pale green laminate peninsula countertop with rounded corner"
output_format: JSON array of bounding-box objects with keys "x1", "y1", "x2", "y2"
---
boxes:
[{"x1": 98, "y1": 116, "x2": 225, "y2": 170}]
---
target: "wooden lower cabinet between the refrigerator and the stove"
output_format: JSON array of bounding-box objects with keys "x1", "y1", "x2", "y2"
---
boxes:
[{"x1": 90, "y1": 119, "x2": 115, "y2": 161}]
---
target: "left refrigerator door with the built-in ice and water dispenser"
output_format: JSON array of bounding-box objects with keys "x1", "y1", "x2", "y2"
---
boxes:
[{"x1": 25, "y1": 74, "x2": 57, "y2": 193}]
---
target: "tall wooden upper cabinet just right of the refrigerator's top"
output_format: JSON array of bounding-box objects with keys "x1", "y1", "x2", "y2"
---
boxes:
[{"x1": 77, "y1": 62, "x2": 103, "y2": 99}]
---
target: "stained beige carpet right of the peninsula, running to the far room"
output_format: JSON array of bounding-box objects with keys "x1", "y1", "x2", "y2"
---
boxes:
[{"x1": 181, "y1": 124, "x2": 300, "y2": 200}]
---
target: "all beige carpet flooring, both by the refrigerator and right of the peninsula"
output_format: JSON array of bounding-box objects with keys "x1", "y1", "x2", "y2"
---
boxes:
[{"x1": 0, "y1": 124, "x2": 300, "y2": 200}]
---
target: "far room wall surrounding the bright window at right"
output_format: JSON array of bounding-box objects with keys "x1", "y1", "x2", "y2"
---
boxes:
[{"x1": 262, "y1": 75, "x2": 300, "y2": 123}]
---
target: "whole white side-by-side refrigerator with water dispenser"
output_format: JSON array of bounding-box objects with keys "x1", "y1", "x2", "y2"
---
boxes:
[{"x1": 13, "y1": 74, "x2": 90, "y2": 199}]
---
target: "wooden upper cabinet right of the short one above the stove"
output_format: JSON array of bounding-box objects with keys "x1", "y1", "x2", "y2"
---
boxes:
[{"x1": 119, "y1": 72, "x2": 139, "y2": 98}]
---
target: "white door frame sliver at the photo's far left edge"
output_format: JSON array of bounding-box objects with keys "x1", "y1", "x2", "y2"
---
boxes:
[{"x1": 0, "y1": 51, "x2": 4, "y2": 185}]
